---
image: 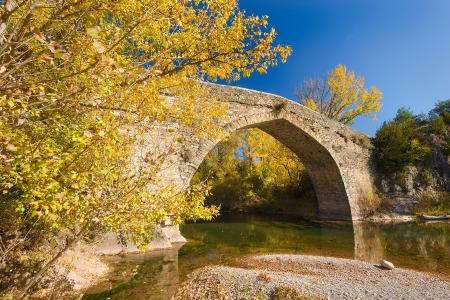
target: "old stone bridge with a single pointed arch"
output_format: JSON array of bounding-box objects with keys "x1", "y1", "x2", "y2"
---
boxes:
[{"x1": 139, "y1": 85, "x2": 373, "y2": 220}]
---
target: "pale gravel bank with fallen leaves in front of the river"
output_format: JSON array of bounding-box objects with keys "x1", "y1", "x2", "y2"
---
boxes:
[{"x1": 173, "y1": 255, "x2": 450, "y2": 300}]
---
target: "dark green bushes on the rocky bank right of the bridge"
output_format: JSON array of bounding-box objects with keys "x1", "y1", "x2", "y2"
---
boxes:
[{"x1": 373, "y1": 100, "x2": 450, "y2": 215}]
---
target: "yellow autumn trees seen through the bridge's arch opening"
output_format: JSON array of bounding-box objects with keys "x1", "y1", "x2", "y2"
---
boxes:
[{"x1": 191, "y1": 128, "x2": 312, "y2": 213}]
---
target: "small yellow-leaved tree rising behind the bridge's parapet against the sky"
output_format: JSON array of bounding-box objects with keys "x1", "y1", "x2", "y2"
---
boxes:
[{"x1": 296, "y1": 65, "x2": 382, "y2": 125}]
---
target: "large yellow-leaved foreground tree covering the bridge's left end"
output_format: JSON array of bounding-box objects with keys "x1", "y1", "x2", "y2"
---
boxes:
[{"x1": 0, "y1": 0, "x2": 291, "y2": 296}]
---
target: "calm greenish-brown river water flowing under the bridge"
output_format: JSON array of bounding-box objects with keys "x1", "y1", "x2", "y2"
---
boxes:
[{"x1": 83, "y1": 215, "x2": 450, "y2": 299}]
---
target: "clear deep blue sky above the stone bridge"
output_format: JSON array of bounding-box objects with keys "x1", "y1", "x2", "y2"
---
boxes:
[{"x1": 233, "y1": 0, "x2": 450, "y2": 135}]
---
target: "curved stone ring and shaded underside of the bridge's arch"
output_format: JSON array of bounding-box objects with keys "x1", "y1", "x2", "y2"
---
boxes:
[{"x1": 187, "y1": 113, "x2": 352, "y2": 220}]
